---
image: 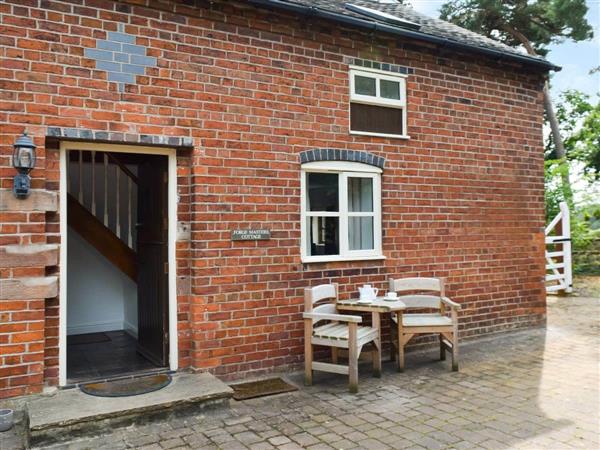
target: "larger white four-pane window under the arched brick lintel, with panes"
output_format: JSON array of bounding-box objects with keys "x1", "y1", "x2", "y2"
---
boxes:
[{"x1": 301, "y1": 161, "x2": 383, "y2": 262}]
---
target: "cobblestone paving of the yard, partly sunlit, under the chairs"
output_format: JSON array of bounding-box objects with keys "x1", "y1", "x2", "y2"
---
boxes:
[{"x1": 2, "y1": 297, "x2": 600, "y2": 450}]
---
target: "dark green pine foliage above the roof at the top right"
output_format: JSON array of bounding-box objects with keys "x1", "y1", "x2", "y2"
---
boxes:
[{"x1": 440, "y1": 0, "x2": 593, "y2": 55}]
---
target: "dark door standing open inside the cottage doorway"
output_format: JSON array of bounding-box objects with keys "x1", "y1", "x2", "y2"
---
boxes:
[{"x1": 137, "y1": 155, "x2": 169, "y2": 366}]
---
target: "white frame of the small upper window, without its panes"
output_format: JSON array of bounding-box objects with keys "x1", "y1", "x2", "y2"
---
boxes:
[{"x1": 348, "y1": 66, "x2": 410, "y2": 139}]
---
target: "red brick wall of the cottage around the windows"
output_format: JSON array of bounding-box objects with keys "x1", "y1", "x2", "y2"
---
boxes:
[{"x1": 0, "y1": 0, "x2": 545, "y2": 394}]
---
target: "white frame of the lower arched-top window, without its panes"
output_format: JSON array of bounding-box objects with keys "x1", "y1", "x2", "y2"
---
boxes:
[{"x1": 300, "y1": 161, "x2": 385, "y2": 263}]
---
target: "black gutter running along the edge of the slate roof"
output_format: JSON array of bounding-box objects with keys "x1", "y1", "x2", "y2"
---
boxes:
[{"x1": 247, "y1": 0, "x2": 562, "y2": 72}]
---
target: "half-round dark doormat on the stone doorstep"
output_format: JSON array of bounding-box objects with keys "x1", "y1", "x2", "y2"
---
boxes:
[{"x1": 79, "y1": 373, "x2": 171, "y2": 397}]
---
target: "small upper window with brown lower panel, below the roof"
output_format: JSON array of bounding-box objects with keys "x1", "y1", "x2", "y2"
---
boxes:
[{"x1": 350, "y1": 67, "x2": 408, "y2": 138}]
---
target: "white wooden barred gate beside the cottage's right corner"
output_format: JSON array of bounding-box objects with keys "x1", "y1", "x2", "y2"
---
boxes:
[{"x1": 545, "y1": 202, "x2": 573, "y2": 293}]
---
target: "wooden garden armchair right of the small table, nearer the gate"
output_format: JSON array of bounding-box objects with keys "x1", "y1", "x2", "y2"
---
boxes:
[{"x1": 389, "y1": 278, "x2": 461, "y2": 372}]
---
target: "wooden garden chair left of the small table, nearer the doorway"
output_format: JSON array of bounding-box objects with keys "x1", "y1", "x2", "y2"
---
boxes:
[{"x1": 303, "y1": 283, "x2": 381, "y2": 393}]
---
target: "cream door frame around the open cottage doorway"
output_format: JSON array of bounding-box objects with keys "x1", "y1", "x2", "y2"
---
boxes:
[{"x1": 58, "y1": 141, "x2": 178, "y2": 386}]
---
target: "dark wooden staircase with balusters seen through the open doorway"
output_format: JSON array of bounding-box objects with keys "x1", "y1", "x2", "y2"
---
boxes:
[{"x1": 67, "y1": 151, "x2": 138, "y2": 282}]
